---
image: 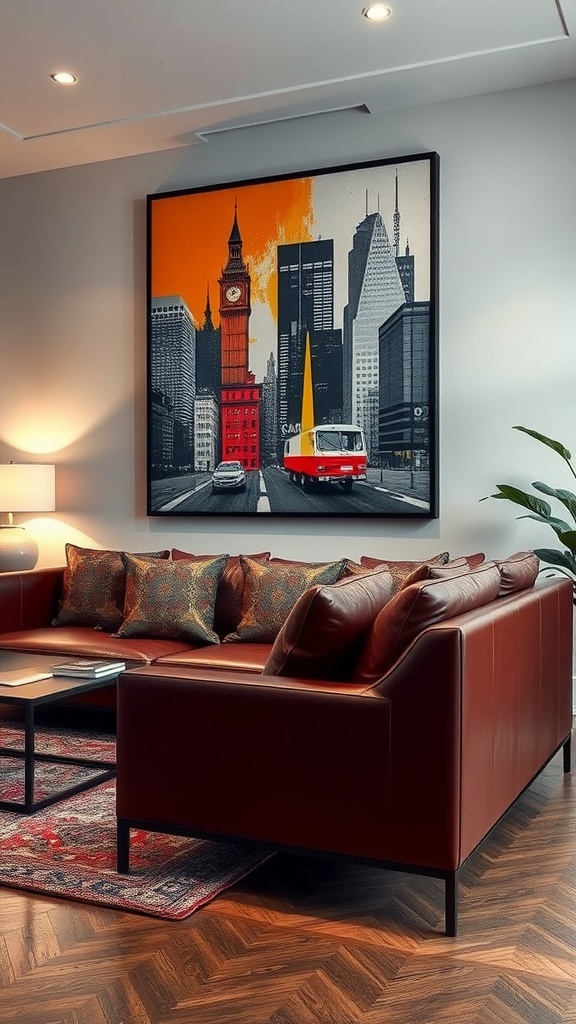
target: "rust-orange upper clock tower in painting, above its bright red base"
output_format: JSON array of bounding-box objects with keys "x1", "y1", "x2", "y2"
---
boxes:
[{"x1": 218, "y1": 206, "x2": 251, "y2": 385}]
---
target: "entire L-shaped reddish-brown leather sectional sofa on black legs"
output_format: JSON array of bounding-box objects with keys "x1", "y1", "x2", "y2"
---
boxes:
[{"x1": 0, "y1": 555, "x2": 573, "y2": 935}]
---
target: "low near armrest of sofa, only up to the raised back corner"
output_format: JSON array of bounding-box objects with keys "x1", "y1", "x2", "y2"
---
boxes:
[{"x1": 117, "y1": 666, "x2": 390, "y2": 855}]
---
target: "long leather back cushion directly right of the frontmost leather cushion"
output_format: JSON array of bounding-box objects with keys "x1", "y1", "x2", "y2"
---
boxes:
[{"x1": 354, "y1": 562, "x2": 500, "y2": 684}]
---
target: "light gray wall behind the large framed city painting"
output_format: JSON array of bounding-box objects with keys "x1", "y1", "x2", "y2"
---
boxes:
[{"x1": 0, "y1": 82, "x2": 576, "y2": 564}]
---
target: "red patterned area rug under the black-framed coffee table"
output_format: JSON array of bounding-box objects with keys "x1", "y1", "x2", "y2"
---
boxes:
[{"x1": 0, "y1": 723, "x2": 274, "y2": 921}]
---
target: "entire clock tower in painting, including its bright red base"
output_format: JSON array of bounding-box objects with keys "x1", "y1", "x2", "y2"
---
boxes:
[{"x1": 218, "y1": 205, "x2": 261, "y2": 479}]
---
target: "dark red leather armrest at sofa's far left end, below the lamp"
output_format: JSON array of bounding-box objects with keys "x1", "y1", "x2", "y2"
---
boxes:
[{"x1": 0, "y1": 566, "x2": 64, "y2": 633}]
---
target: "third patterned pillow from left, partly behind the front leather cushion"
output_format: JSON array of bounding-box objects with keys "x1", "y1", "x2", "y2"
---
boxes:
[{"x1": 224, "y1": 555, "x2": 346, "y2": 643}]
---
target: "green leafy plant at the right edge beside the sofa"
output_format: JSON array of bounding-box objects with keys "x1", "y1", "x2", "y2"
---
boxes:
[{"x1": 481, "y1": 426, "x2": 576, "y2": 604}]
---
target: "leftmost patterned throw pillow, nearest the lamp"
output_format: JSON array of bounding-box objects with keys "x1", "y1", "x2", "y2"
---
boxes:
[{"x1": 52, "y1": 544, "x2": 170, "y2": 633}]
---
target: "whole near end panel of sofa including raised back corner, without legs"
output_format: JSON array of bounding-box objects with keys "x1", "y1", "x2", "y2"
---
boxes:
[{"x1": 117, "y1": 655, "x2": 460, "y2": 869}]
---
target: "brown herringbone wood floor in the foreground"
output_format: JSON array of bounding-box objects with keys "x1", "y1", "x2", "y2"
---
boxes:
[{"x1": 0, "y1": 737, "x2": 576, "y2": 1024}]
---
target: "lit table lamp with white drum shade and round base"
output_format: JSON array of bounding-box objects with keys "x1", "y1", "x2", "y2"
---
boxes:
[{"x1": 0, "y1": 462, "x2": 55, "y2": 572}]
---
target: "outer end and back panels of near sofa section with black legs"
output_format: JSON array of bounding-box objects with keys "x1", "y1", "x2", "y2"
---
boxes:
[{"x1": 117, "y1": 580, "x2": 572, "y2": 935}]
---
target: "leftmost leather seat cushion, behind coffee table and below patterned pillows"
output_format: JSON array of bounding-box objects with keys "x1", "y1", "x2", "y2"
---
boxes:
[{"x1": 0, "y1": 626, "x2": 190, "y2": 665}]
